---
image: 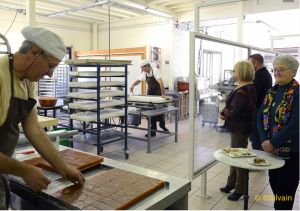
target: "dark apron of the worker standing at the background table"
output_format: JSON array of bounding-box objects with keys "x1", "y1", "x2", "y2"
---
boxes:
[{"x1": 146, "y1": 74, "x2": 165, "y2": 130}]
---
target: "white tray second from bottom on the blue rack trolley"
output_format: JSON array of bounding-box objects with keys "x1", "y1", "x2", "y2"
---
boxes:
[{"x1": 69, "y1": 100, "x2": 124, "y2": 111}]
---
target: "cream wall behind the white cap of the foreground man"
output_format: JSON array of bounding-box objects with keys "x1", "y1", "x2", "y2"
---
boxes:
[{"x1": 0, "y1": 9, "x2": 91, "y2": 52}]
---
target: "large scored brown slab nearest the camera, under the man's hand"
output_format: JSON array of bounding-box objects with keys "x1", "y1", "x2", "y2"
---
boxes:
[{"x1": 52, "y1": 169, "x2": 165, "y2": 210}]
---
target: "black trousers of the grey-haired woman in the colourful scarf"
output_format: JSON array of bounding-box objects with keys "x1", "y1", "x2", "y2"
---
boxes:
[{"x1": 269, "y1": 152, "x2": 299, "y2": 210}]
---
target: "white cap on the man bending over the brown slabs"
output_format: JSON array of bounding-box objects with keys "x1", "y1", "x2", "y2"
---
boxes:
[{"x1": 22, "y1": 26, "x2": 66, "y2": 60}]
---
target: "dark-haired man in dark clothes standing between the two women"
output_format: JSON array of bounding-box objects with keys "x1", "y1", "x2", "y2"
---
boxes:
[{"x1": 249, "y1": 54, "x2": 272, "y2": 150}]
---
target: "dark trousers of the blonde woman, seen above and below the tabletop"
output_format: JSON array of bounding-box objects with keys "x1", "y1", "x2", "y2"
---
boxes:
[{"x1": 227, "y1": 133, "x2": 248, "y2": 194}]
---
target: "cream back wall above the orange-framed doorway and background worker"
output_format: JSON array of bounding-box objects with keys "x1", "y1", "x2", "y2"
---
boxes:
[{"x1": 98, "y1": 17, "x2": 173, "y2": 87}]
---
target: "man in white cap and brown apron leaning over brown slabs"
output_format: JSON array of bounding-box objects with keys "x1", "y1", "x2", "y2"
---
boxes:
[{"x1": 0, "y1": 26, "x2": 84, "y2": 209}]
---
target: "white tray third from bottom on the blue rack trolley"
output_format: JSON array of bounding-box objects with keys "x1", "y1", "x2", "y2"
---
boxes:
[{"x1": 68, "y1": 90, "x2": 125, "y2": 100}]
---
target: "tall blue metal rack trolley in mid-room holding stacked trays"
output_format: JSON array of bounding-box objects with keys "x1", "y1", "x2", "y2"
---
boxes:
[{"x1": 66, "y1": 59, "x2": 131, "y2": 159}]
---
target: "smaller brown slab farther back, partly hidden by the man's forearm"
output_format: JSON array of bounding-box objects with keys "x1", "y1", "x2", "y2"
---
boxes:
[{"x1": 23, "y1": 149, "x2": 103, "y2": 172}]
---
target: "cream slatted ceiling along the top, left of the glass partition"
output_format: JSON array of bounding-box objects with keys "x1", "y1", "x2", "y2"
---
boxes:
[{"x1": 0, "y1": 0, "x2": 203, "y2": 23}]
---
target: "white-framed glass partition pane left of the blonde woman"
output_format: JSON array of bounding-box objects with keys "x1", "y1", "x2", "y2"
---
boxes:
[{"x1": 189, "y1": 33, "x2": 277, "y2": 178}]
